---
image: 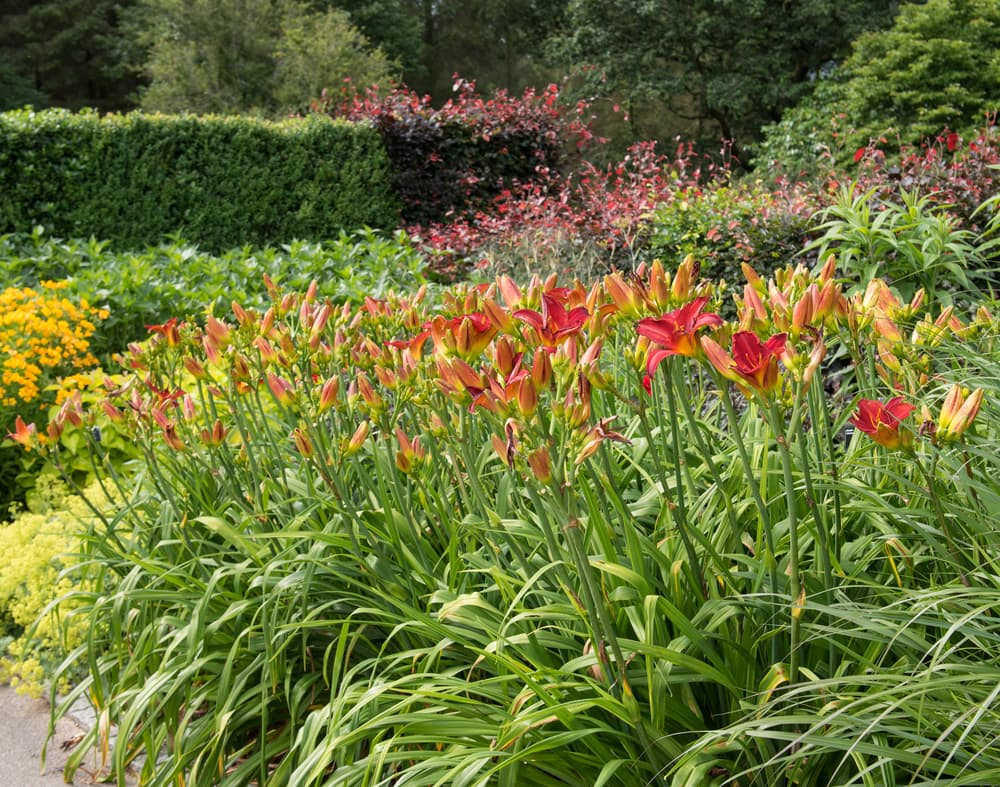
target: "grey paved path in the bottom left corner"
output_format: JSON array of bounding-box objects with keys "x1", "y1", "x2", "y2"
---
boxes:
[{"x1": 0, "y1": 685, "x2": 133, "y2": 787}]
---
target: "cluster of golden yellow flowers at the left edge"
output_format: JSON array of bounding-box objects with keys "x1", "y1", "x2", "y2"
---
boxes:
[{"x1": 0, "y1": 282, "x2": 108, "y2": 416}]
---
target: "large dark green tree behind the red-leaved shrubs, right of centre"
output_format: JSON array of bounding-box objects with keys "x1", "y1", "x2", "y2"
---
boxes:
[{"x1": 552, "y1": 0, "x2": 897, "y2": 159}]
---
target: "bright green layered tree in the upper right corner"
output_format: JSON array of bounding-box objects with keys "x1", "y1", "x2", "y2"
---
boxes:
[{"x1": 757, "y1": 0, "x2": 1000, "y2": 170}]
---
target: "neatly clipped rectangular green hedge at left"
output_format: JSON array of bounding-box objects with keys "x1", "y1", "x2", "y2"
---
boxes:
[{"x1": 0, "y1": 110, "x2": 398, "y2": 251}]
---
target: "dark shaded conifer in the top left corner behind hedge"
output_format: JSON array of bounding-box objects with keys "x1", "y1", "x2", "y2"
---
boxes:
[{"x1": 0, "y1": 0, "x2": 137, "y2": 110}]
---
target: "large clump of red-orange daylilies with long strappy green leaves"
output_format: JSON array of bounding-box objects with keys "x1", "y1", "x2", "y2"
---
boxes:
[{"x1": 19, "y1": 254, "x2": 1000, "y2": 787}]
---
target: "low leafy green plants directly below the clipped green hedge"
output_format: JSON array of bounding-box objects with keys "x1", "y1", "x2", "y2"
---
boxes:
[{"x1": 0, "y1": 227, "x2": 426, "y2": 358}]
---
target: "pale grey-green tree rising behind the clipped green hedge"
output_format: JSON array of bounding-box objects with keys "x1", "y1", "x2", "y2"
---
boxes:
[{"x1": 141, "y1": 0, "x2": 398, "y2": 114}]
